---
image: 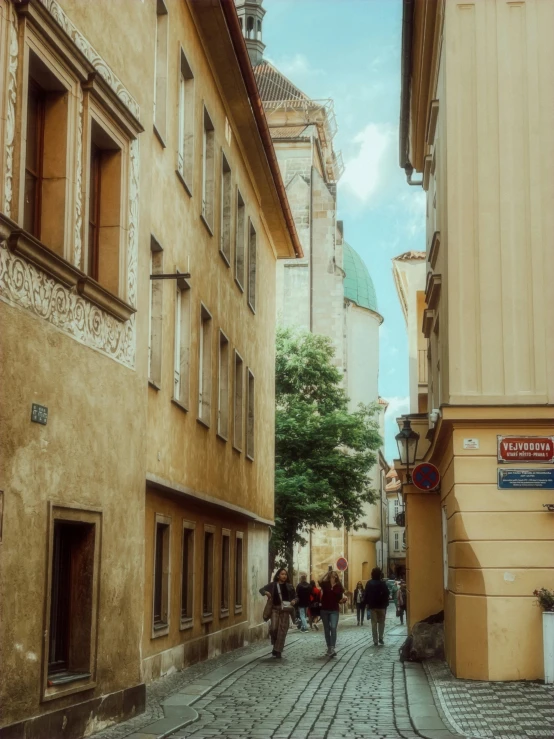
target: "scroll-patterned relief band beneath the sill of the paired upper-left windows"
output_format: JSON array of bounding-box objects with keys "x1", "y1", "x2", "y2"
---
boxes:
[{"x1": 0, "y1": 241, "x2": 136, "y2": 368}]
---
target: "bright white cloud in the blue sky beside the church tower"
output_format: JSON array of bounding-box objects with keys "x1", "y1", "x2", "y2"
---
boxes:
[{"x1": 341, "y1": 123, "x2": 397, "y2": 204}]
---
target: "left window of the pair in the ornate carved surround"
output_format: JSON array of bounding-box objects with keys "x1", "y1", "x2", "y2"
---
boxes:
[{"x1": 23, "y1": 50, "x2": 70, "y2": 256}]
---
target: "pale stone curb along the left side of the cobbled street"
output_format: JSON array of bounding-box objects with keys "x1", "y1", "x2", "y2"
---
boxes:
[{"x1": 126, "y1": 636, "x2": 301, "y2": 739}]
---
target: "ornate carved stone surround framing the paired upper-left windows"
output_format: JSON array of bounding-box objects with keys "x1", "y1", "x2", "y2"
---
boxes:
[{"x1": 0, "y1": 0, "x2": 143, "y2": 367}]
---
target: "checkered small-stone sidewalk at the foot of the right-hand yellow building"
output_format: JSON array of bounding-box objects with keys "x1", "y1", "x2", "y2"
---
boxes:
[{"x1": 425, "y1": 662, "x2": 554, "y2": 739}]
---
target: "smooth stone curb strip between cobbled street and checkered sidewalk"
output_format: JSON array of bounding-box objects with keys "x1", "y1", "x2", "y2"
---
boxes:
[{"x1": 404, "y1": 662, "x2": 471, "y2": 739}]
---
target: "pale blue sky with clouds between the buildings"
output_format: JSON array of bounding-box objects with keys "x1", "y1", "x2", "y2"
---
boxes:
[{"x1": 263, "y1": 0, "x2": 425, "y2": 461}]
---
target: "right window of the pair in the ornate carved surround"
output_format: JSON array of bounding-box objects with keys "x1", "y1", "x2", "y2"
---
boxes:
[{"x1": 85, "y1": 118, "x2": 123, "y2": 295}]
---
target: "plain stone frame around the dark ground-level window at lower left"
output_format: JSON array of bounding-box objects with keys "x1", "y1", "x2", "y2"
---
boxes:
[{"x1": 40, "y1": 502, "x2": 102, "y2": 702}]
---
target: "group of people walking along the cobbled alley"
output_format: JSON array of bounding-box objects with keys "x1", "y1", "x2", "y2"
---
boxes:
[{"x1": 260, "y1": 567, "x2": 406, "y2": 659}]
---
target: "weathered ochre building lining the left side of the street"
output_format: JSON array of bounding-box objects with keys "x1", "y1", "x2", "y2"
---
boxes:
[{"x1": 0, "y1": 0, "x2": 302, "y2": 738}]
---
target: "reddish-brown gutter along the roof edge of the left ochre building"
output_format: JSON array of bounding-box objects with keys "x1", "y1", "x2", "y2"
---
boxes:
[{"x1": 219, "y1": 0, "x2": 304, "y2": 259}]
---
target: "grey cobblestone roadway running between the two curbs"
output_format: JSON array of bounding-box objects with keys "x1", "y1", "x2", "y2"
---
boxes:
[{"x1": 168, "y1": 617, "x2": 416, "y2": 739}]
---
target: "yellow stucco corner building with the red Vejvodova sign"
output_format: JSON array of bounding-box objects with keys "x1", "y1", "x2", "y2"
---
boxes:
[{"x1": 397, "y1": 0, "x2": 554, "y2": 680}]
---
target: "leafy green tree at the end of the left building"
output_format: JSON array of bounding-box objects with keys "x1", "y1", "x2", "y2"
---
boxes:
[{"x1": 270, "y1": 328, "x2": 381, "y2": 571}]
